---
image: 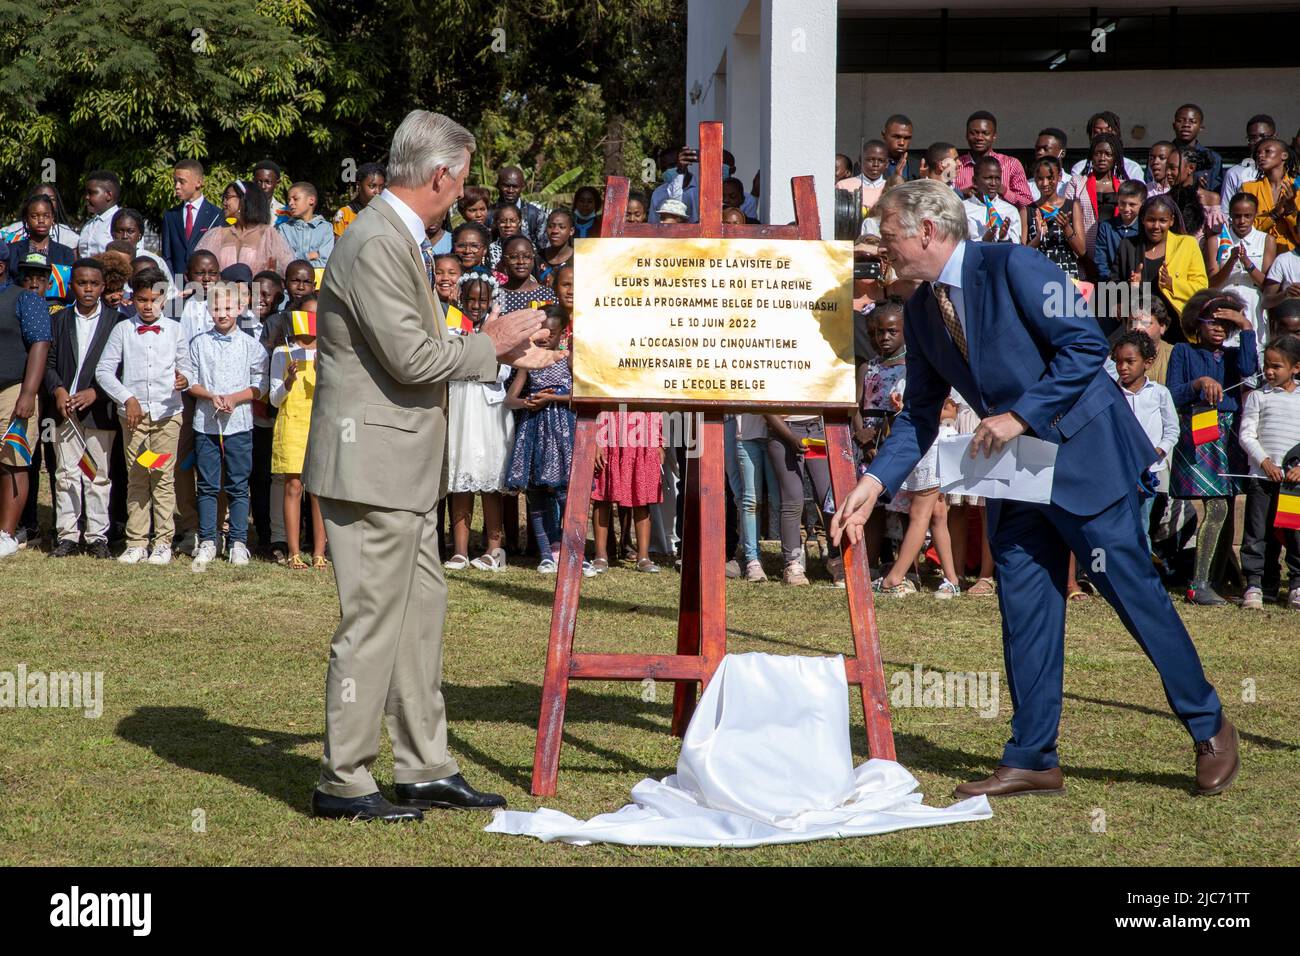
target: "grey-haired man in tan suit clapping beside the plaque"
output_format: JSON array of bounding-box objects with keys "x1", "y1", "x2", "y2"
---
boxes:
[{"x1": 303, "y1": 111, "x2": 554, "y2": 821}]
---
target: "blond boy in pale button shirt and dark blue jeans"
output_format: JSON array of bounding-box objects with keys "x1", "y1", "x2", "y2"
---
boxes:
[{"x1": 190, "y1": 282, "x2": 267, "y2": 571}]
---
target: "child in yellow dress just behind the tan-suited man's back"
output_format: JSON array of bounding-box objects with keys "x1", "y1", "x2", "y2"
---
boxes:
[{"x1": 270, "y1": 311, "x2": 329, "y2": 571}]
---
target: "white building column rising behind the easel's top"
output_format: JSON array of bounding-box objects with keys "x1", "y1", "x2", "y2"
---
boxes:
[{"x1": 759, "y1": 0, "x2": 839, "y2": 239}]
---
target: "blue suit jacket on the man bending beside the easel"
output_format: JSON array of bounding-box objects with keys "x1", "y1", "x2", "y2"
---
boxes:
[{"x1": 867, "y1": 242, "x2": 1156, "y2": 515}]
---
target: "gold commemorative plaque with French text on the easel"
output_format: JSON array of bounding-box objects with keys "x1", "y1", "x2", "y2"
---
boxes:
[{"x1": 573, "y1": 238, "x2": 854, "y2": 406}]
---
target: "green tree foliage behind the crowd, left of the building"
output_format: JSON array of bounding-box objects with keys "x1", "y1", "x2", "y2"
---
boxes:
[{"x1": 0, "y1": 0, "x2": 685, "y2": 219}]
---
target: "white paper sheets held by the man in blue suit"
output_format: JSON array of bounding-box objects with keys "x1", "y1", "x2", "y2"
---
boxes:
[{"x1": 937, "y1": 434, "x2": 1057, "y2": 505}]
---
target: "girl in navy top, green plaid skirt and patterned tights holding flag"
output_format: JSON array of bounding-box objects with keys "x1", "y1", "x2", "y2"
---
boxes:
[{"x1": 1167, "y1": 289, "x2": 1258, "y2": 605}]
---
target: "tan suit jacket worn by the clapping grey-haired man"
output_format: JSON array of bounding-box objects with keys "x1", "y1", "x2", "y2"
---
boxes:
[{"x1": 303, "y1": 198, "x2": 497, "y2": 512}]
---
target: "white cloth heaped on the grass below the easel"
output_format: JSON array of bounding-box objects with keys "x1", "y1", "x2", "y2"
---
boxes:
[{"x1": 485, "y1": 654, "x2": 993, "y2": 847}]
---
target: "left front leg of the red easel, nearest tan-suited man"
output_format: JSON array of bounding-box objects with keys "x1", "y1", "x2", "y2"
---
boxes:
[{"x1": 532, "y1": 411, "x2": 597, "y2": 796}]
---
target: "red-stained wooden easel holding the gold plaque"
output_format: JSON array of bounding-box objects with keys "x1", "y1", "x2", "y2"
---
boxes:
[{"x1": 532, "y1": 122, "x2": 894, "y2": 796}]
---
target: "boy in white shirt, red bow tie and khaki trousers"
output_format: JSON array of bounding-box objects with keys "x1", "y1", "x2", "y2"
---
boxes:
[{"x1": 95, "y1": 268, "x2": 190, "y2": 564}]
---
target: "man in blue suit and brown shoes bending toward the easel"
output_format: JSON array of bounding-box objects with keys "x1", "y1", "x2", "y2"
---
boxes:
[{"x1": 831, "y1": 179, "x2": 1240, "y2": 797}]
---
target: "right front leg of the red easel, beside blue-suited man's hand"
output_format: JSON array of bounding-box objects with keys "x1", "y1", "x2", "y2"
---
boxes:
[{"x1": 826, "y1": 418, "x2": 896, "y2": 760}]
